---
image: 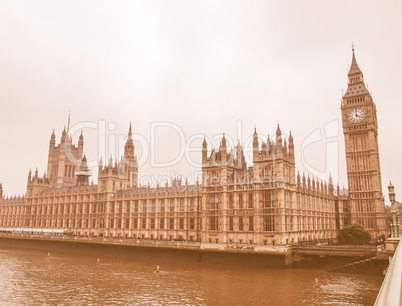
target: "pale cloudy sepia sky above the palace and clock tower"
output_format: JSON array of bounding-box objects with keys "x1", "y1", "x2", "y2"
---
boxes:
[{"x1": 0, "y1": 0, "x2": 402, "y2": 203}]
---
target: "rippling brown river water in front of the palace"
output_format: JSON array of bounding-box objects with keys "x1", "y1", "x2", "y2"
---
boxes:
[{"x1": 0, "y1": 241, "x2": 383, "y2": 305}]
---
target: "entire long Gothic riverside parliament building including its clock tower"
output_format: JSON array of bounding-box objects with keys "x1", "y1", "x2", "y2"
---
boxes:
[{"x1": 0, "y1": 50, "x2": 386, "y2": 250}]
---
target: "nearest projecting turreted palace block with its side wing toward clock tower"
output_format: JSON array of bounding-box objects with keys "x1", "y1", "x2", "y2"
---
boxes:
[{"x1": 201, "y1": 125, "x2": 348, "y2": 245}]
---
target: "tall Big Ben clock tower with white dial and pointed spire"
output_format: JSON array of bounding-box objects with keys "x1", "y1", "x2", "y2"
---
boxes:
[{"x1": 341, "y1": 47, "x2": 386, "y2": 238}]
